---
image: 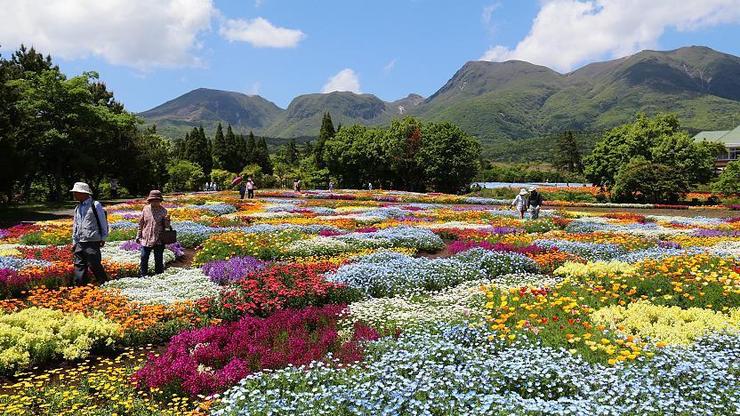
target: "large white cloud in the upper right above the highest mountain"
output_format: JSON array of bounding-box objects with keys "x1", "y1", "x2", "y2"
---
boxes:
[{"x1": 481, "y1": 0, "x2": 740, "y2": 71}]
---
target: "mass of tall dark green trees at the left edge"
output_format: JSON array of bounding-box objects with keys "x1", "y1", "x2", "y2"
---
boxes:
[{"x1": 0, "y1": 47, "x2": 170, "y2": 202}]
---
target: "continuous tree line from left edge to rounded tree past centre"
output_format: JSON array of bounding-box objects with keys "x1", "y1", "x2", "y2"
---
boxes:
[{"x1": 0, "y1": 46, "x2": 480, "y2": 203}]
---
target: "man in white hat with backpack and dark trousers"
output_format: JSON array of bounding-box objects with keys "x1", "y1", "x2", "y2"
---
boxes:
[{"x1": 71, "y1": 182, "x2": 108, "y2": 285}]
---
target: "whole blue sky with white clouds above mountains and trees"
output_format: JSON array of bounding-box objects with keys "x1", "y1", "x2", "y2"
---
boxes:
[{"x1": 0, "y1": 0, "x2": 740, "y2": 112}]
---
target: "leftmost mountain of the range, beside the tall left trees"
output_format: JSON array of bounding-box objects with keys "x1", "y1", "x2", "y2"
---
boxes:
[{"x1": 139, "y1": 88, "x2": 285, "y2": 137}]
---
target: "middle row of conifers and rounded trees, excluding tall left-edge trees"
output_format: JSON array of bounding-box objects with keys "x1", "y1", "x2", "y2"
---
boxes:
[{"x1": 171, "y1": 112, "x2": 480, "y2": 192}]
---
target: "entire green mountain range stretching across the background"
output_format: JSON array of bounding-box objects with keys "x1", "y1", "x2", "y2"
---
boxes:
[{"x1": 139, "y1": 46, "x2": 740, "y2": 145}]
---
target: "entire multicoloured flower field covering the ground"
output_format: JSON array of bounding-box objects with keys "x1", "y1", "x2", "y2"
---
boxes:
[{"x1": 0, "y1": 191, "x2": 740, "y2": 416}]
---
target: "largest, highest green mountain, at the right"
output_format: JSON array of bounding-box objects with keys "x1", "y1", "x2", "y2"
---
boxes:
[{"x1": 416, "y1": 47, "x2": 740, "y2": 143}]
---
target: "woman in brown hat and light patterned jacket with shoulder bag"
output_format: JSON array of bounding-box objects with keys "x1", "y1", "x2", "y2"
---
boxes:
[{"x1": 136, "y1": 190, "x2": 170, "y2": 277}]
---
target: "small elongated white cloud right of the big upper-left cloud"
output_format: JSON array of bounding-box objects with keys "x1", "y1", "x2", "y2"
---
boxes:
[{"x1": 219, "y1": 17, "x2": 306, "y2": 48}]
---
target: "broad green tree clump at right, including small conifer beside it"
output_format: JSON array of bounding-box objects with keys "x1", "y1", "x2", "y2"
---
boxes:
[{"x1": 553, "y1": 114, "x2": 740, "y2": 203}]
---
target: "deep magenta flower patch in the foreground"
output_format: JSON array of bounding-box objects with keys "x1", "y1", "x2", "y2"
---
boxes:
[{"x1": 136, "y1": 306, "x2": 378, "y2": 394}]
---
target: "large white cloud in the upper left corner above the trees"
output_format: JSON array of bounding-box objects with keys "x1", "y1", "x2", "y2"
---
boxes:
[{"x1": 0, "y1": 0, "x2": 218, "y2": 70}]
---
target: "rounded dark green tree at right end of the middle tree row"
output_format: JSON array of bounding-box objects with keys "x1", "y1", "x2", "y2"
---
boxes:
[{"x1": 416, "y1": 122, "x2": 480, "y2": 193}]
